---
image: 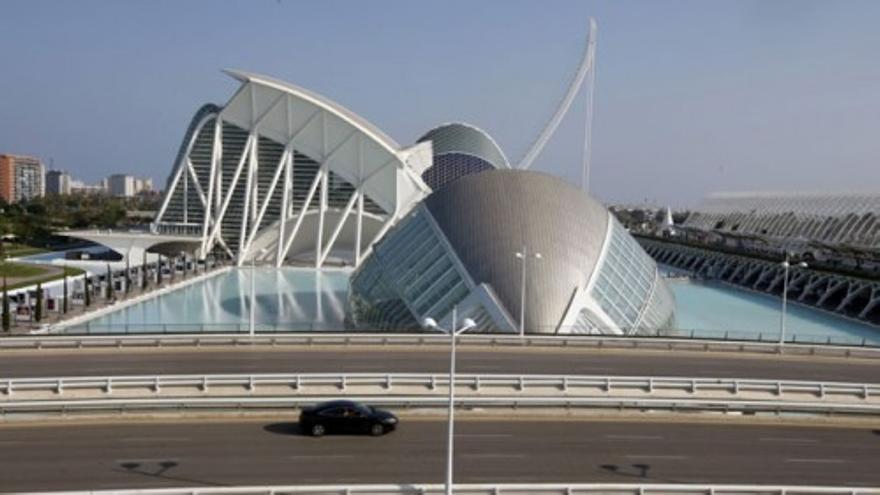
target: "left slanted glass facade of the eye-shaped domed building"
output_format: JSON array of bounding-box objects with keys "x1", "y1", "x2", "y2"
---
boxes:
[{"x1": 349, "y1": 207, "x2": 470, "y2": 330}]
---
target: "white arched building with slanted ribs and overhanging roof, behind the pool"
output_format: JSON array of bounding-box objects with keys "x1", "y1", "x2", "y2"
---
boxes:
[{"x1": 153, "y1": 70, "x2": 431, "y2": 267}]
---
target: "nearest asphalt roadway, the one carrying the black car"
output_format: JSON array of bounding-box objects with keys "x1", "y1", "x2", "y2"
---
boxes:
[{"x1": 0, "y1": 417, "x2": 880, "y2": 492}]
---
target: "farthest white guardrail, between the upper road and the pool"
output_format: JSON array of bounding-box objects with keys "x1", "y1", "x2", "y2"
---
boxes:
[{"x1": 0, "y1": 332, "x2": 880, "y2": 359}]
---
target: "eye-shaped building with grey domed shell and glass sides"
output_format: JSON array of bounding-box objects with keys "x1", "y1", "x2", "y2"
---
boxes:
[{"x1": 348, "y1": 169, "x2": 675, "y2": 334}]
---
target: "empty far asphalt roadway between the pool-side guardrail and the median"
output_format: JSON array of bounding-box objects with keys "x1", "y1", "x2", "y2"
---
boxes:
[{"x1": 0, "y1": 347, "x2": 880, "y2": 383}]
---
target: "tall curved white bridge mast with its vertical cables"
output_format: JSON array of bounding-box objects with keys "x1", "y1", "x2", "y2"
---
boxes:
[{"x1": 517, "y1": 17, "x2": 597, "y2": 188}]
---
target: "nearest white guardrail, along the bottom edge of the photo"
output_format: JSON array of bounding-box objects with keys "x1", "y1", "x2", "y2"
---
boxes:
[{"x1": 24, "y1": 483, "x2": 880, "y2": 495}]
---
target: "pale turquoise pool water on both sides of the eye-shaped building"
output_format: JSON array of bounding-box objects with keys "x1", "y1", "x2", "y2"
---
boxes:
[{"x1": 65, "y1": 267, "x2": 880, "y2": 345}]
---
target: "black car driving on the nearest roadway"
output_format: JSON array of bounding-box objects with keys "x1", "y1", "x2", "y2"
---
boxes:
[{"x1": 299, "y1": 400, "x2": 397, "y2": 437}]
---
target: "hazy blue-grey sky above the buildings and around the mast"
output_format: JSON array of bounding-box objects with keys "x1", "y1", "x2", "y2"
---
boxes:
[{"x1": 0, "y1": 0, "x2": 880, "y2": 206}]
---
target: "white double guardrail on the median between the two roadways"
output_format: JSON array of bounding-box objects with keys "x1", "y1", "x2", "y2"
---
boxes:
[{"x1": 0, "y1": 373, "x2": 880, "y2": 415}]
